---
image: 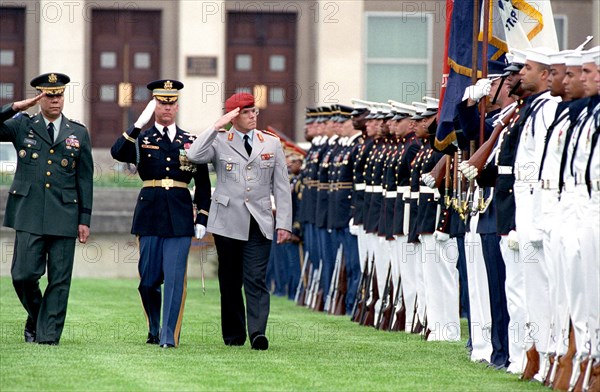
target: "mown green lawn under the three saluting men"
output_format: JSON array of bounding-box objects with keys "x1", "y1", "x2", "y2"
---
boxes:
[{"x1": 0, "y1": 278, "x2": 546, "y2": 391}]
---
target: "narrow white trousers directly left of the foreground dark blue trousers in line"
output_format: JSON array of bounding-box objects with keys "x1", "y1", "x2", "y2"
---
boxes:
[{"x1": 465, "y1": 215, "x2": 493, "y2": 362}]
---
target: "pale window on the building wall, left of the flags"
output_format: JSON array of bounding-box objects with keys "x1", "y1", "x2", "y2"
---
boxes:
[{"x1": 365, "y1": 12, "x2": 433, "y2": 103}]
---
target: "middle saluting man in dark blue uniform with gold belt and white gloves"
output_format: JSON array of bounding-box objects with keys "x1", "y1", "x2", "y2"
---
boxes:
[{"x1": 111, "y1": 80, "x2": 210, "y2": 348}]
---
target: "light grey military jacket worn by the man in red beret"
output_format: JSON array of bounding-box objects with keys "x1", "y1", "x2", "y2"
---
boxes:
[{"x1": 187, "y1": 128, "x2": 292, "y2": 241}]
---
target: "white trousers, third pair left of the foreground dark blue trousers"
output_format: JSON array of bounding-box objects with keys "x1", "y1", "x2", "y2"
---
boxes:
[{"x1": 396, "y1": 235, "x2": 419, "y2": 332}]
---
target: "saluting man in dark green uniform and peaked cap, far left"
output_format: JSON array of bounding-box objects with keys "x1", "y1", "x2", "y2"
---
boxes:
[{"x1": 0, "y1": 73, "x2": 94, "y2": 345}]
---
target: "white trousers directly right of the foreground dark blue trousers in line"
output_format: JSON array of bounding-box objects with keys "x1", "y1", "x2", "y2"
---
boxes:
[{"x1": 500, "y1": 236, "x2": 527, "y2": 373}]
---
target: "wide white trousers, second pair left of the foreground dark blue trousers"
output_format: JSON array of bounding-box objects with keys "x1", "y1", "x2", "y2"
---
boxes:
[{"x1": 421, "y1": 234, "x2": 460, "y2": 341}]
